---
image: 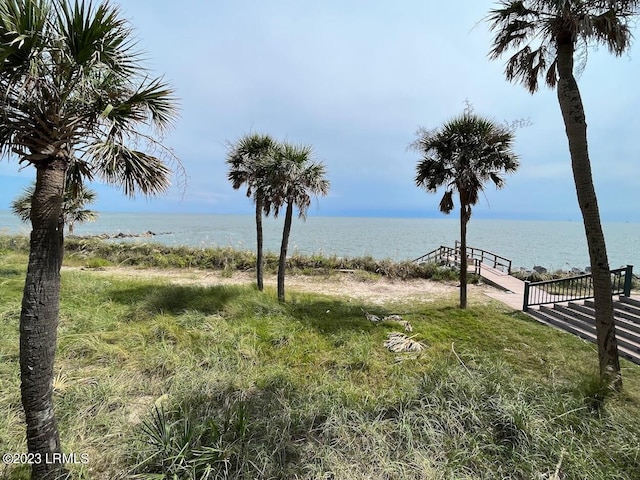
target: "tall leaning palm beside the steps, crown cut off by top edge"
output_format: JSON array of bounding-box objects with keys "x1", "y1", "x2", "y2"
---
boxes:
[{"x1": 488, "y1": 0, "x2": 640, "y2": 390}]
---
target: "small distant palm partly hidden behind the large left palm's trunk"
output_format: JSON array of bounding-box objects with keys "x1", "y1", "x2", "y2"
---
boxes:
[{"x1": 11, "y1": 183, "x2": 98, "y2": 235}]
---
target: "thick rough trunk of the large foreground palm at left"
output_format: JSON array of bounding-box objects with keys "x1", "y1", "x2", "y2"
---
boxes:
[{"x1": 20, "y1": 159, "x2": 66, "y2": 480}]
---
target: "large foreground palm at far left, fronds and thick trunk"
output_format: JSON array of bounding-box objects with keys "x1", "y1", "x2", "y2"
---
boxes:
[{"x1": 0, "y1": 0, "x2": 179, "y2": 480}]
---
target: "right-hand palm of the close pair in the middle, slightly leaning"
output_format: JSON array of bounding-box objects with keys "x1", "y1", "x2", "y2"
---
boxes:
[{"x1": 264, "y1": 142, "x2": 329, "y2": 302}]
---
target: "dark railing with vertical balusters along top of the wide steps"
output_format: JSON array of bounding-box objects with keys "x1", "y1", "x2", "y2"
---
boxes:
[{"x1": 522, "y1": 265, "x2": 633, "y2": 312}]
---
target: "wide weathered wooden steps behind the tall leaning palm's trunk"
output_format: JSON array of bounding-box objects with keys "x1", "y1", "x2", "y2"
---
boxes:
[{"x1": 527, "y1": 296, "x2": 640, "y2": 365}]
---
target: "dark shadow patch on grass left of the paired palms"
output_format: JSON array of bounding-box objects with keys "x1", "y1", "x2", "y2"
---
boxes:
[{"x1": 109, "y1": 285, "x2": 244, "y2": 315}]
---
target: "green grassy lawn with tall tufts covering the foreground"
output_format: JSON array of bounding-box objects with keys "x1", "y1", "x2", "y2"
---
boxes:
[{"x1": 0, "y1": 249, "x2": 640, "y2": 480}]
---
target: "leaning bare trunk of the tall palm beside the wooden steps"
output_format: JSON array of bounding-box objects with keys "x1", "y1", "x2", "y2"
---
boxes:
[{"x1": 558, "y1": 40, "x2": 622, "y2": 391}]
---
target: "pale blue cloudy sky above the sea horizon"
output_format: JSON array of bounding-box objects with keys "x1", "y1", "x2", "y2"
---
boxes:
[{"x1": 0, "y1": 0, "x2": 640, "y2": 222}]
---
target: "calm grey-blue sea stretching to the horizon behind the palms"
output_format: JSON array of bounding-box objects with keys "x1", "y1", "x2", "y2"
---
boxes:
[{"x1": 0, "y1": 211, "x2": 640, "y2": 271}]
